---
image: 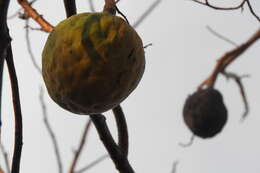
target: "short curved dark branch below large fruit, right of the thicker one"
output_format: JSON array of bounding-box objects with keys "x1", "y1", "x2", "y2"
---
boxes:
[{"x1": 113, "y1": 105, "x2": 129, "y2": 157}]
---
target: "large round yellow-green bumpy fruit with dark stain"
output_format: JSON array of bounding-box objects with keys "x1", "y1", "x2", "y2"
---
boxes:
[{"x1": 42, "y1": 12, "x2": 145, "y2": 115}]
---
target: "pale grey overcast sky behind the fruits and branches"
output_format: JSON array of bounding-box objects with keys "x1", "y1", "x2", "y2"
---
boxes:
[{"x1": 0, "y1": 0, "x2": 260, "y2": 173}]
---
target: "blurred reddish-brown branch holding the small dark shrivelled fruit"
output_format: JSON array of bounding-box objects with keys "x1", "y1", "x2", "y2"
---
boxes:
[{"x1": 198, "y1": 29, "x2": 260, "y2": 89}]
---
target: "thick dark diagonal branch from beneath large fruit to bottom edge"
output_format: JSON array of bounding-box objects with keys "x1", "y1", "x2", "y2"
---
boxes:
[{"x1": 90, "y1": 114, "x2": 134, "y2": 173}]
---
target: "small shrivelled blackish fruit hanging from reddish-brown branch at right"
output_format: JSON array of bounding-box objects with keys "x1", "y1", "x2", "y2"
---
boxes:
[{"x1": 183, "y1": 88, "x2": 228, "y2": 138}]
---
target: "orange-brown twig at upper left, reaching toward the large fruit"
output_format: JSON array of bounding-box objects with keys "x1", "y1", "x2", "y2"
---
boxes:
[{"x1": 17, "y1": 0, "x2": 53, "y2": 32}]
